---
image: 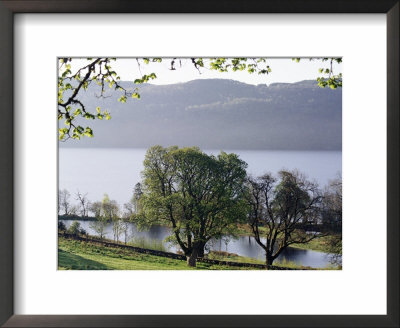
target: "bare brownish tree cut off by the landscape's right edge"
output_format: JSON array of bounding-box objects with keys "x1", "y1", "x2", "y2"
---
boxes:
[{"x1": 322, "y1": 177, "x2": 342, "y2": 265}]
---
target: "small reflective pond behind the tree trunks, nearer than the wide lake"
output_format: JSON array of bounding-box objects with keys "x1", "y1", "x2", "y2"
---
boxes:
[{"x1": 63, "y1": 220, "x2": 330, "y2": 268}]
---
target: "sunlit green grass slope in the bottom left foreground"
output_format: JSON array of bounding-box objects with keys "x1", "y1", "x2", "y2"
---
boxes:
[{"x1": 58, "y1": 237, "x2": 255, "y2": 270}]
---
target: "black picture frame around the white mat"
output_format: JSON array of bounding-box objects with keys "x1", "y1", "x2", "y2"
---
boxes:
[{"x1": 0, "y1": 0, "x2": 400, "y2": 327}]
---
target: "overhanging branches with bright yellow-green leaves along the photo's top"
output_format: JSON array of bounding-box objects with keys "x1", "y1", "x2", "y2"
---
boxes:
[{"x1": 58, "y1": 57, "x2": 342, "y2": 141}]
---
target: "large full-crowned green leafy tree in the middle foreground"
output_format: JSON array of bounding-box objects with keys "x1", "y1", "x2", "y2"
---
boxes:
[{"x1": 140, "y1": 146, "x2": 247, "y2": 267}]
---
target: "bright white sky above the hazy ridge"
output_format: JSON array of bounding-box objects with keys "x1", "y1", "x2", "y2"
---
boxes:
[{"x1": 68, "y1": 58, "x2": 343, "y2": 85}]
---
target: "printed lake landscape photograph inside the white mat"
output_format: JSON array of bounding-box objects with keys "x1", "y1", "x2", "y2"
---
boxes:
[{"x1": 58, "y1": 57, "x2": 343, "y2": 270}]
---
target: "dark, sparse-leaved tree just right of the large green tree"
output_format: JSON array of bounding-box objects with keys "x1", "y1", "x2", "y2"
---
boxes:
[{"x1": 247, "y1": 171, "x2": 322, "y2": 268}]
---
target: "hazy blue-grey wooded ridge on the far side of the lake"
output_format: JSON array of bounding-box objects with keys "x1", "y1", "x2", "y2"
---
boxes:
[{"x1": 60, "y1": 79, "x2": 342, "y2": 150}]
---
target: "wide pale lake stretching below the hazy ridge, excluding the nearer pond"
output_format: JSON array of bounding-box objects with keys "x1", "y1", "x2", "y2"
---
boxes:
[{"x1": 59, "y1": 148, "x2": 342, "y2": 205}]
